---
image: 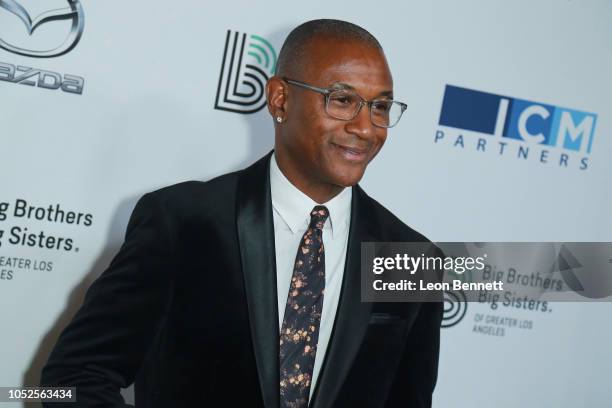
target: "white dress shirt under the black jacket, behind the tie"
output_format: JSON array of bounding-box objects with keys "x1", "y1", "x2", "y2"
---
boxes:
[{"x1": 270, "y1": 154, "x2": 352, "y2": 398}]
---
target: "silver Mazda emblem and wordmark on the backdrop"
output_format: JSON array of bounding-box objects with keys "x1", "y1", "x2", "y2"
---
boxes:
[{"x1": 0, "y1": 0, "x2": 85, "y2": 95}]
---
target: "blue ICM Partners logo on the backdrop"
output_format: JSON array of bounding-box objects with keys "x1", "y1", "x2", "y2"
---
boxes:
[{"x1": 434, "y1": 85, "x2": 597, "y2": 170}]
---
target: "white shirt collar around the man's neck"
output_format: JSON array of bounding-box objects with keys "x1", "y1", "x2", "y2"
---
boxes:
[{"x1": 270, "y1": 153, "x2": 352, "y2": 239}]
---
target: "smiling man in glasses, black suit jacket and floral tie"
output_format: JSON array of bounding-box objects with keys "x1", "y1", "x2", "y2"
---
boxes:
[{"x1": 42, "y1": 20, "x2": 442, "y2": 408}]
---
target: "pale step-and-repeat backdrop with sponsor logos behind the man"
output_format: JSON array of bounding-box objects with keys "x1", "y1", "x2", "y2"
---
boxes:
[{"x1": 0, "y1": 0, "x2": 612, "y2": 408}]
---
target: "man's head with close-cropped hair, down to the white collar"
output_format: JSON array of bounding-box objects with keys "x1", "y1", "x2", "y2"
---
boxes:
[{"x1": 266, "y1": 20, "x2": 393, "y2": 203}]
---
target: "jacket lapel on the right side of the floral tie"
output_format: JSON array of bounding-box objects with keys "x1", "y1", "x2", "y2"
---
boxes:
[{"x1": 310, "y1": 186, "x2": 377, "y2": 408}]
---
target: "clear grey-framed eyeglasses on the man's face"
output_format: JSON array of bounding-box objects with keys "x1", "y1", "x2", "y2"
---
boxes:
[{"x1": 283, "y1": 77, "x2": 408, "y2": 128}]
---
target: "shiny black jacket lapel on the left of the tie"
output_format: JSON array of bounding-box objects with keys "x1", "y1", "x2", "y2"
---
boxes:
[{"x1": 236, "y1": 154, "x2": 280, "y2": 408}]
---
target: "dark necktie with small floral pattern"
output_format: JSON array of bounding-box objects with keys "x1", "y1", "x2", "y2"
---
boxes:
[{"x1": 280, "y1": 205, "x2": 329, "y2": 408}]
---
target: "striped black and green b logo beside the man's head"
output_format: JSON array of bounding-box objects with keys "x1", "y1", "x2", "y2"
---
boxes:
[{"x1": 215, "y1": 30, "x2": 276, "y2": 113}]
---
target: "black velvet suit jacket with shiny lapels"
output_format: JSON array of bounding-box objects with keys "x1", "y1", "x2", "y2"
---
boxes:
[{"x1": 42, "y1": 154, "x2": 442, "y2": 408}]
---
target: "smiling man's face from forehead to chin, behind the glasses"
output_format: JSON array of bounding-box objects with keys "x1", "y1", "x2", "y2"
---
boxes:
[{"x1": 276, "y1": 37, "x2": 393, "y2": 187}]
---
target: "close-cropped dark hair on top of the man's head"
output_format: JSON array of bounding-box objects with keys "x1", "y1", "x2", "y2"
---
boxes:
[{"x1": 276, "y1": 19, "x2": 382, "y2": 78}]
